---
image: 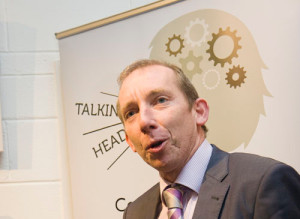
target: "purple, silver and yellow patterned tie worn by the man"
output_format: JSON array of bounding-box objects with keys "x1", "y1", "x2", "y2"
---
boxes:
[{"x1": 163, "y1": 186, "x2": 183, "y2": 219}]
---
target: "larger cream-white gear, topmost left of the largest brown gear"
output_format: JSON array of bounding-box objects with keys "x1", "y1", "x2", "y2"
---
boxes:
[{"x1": 184, "y1": 18, "x2": 209, "y2": 47}]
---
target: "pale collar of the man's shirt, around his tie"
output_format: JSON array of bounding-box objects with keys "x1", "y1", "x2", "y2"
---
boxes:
[{"x1": 160, "y1": 139, "x2": 212, "y2": 194}]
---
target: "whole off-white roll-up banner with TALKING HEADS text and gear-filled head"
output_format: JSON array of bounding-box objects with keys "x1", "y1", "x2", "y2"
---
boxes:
[{"x1": 57, "y1": 0, "x2": 300, "y2": 219}]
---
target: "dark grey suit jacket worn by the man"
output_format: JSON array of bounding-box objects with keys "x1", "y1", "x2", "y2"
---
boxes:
[{"x1": 124, "y1": 146, "x2": 300, "y2": 219}]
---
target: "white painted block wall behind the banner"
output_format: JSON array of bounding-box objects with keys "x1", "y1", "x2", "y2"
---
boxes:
[{"x1": 0, "y1": 0, "x2": 158, "y2": 219}]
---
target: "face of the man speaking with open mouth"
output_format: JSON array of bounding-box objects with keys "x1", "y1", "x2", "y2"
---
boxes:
[{"x1": 119, "y1": 65, "x2": 207, "y2": 180}]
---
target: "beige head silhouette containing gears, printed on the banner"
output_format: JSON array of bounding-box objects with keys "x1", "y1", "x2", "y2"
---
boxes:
[{"x1": 150, "y1": 9, "x2": 270, "y2": 151}]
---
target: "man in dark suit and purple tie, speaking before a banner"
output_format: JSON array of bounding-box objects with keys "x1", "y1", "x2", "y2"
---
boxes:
[{"x1": 117, "y1": 60, "x2": 300, "y2": 219}]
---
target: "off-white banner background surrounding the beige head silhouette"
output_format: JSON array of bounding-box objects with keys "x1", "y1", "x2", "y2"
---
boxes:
[{"x1": 59, "y1": 0, "x2": 300, "y2": 219}]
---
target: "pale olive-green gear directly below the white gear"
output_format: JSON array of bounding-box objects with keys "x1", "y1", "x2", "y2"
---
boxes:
[{"x1": 179, "y1": 50, "x2": 203, "y2": 79}]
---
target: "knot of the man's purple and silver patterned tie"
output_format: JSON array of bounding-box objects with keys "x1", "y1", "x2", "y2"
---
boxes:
[{"x1": 163, "y1": 185, "x2": 183, "y2": 209}]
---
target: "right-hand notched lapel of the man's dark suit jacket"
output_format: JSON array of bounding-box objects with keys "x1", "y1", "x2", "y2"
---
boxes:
[{"x1": 193, "y1": 145, "x2": 230, "y2": 219}]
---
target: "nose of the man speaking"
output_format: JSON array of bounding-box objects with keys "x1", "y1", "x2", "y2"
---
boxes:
[{"x1": 140, "y1": 107, "x2": 157, "y2": 134}]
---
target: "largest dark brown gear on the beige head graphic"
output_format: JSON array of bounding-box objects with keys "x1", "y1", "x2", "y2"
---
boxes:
[{"x1": 206, "y1": 27, "x2": 242, "y2": 67}]
